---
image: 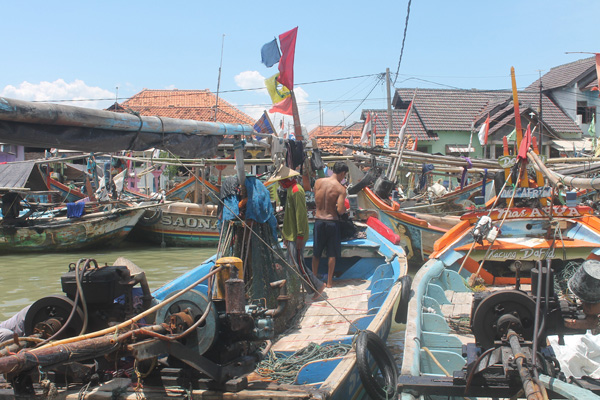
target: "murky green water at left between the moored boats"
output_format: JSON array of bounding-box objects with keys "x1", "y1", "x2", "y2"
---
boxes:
[{"x1": 0, "y1": 245, "x2": 216, "y2": 321}]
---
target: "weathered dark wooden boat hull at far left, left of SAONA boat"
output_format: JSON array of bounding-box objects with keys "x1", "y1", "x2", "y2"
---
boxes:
[{"x1": 0, "y1": 208, "x2": 144, "y2": 254}]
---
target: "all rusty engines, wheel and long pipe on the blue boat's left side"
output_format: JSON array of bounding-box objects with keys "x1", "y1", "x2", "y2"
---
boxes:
[{"x1": 0, "y1": 257, "x2": 289, "y2": 395}]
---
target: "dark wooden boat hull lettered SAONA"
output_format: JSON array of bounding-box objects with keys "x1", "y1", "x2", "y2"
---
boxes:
[{"x1": 131, "y1": 203, "x2": 219, "y2": 247}]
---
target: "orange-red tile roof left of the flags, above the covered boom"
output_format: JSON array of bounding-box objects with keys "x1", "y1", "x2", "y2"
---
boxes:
[{"x1": 111, "y1": 89, "x2": 256, "y2": 125}]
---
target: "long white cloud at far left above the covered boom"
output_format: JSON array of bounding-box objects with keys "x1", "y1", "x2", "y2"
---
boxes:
[{"x1": 0, "y1": 79, "x2": 115, "y2": 108}]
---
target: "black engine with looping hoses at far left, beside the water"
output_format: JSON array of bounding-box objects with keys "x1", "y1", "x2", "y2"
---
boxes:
[{"x1": 24, "y1": 259, "x2": 152, "y2": 339}]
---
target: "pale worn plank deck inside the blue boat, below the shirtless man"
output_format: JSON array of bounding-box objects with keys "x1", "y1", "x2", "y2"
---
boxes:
[{"x1": 273, "y1": 279, "x2": 370, "y2": 352}]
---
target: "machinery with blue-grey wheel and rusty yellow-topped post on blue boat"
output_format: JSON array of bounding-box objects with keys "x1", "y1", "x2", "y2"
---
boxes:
[{"x1": 130, "y1": 257, "x2": 289, "y2": 391}]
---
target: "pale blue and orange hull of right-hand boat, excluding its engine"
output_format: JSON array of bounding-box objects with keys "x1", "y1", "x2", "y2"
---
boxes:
[{"x1": 401, "y1": 206, "x2": 600, "y2": 400}]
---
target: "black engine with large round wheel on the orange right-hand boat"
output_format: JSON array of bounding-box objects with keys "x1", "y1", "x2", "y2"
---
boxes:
[{"x1": 453, "y1": 260, "x2": 600, "y2": 399}]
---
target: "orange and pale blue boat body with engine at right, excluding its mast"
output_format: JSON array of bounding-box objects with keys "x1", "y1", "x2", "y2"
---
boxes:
[{"x1": 401, "y1": 202, "x2": 600, "y2": 399}]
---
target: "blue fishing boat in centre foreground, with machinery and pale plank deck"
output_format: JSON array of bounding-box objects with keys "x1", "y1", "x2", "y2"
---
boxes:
[{"x1": 0, "y1": 211, "x2": 409, "y2": 399}]
